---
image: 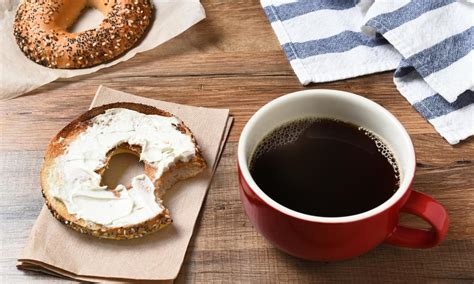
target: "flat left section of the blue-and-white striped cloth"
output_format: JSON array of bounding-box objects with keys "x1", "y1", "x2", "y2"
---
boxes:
[{"x1": 261, "y1": 0, "x2": 402, "y2": 85}]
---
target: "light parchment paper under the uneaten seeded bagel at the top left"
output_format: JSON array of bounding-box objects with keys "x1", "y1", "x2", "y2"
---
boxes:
[{"x1": 0, "y1": 0, "x2": 206, "y2": 100}]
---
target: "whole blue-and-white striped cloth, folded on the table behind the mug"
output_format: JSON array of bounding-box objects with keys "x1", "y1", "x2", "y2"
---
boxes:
[{"x1": 261, "y1": 0, "x2": 474, "y2": 144}]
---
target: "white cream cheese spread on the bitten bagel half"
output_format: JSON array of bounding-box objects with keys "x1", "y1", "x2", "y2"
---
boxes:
[{"x1": 48, "y1": 108, "x2": 196, "y2": 227}]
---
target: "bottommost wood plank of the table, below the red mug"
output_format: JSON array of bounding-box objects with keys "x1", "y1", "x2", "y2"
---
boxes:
[{"x1": 177, "y1": 240, "x2": 474, "y2": 283}]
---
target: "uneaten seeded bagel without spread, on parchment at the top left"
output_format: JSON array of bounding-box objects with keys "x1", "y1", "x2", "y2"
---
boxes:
[{"x1": 13, "y1": 0, "x2": 153, "y2": 69}]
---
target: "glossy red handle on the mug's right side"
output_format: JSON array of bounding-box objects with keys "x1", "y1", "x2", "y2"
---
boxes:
[{"x1": 385, "y1": 191, "x2": 449, "y2": 248}]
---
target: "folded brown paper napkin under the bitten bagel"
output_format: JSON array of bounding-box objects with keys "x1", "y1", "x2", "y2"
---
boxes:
[{"x1": 17, "y1": 87, "x2": 232, "y2": 282}]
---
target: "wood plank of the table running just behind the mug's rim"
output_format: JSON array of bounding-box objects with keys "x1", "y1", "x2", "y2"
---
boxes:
[{"x1": 0, "y1": 73, "x2": 474, "y2": 152}]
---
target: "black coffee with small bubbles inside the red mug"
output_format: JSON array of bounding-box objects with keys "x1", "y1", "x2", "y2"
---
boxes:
[{"x1": 250, "y1": 118, "x2": 399, "y2": 217}]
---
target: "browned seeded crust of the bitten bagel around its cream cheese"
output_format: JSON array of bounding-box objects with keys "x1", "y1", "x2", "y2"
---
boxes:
[{"x1": 41, "y1": 103, "x2": 206, "y2": 240}]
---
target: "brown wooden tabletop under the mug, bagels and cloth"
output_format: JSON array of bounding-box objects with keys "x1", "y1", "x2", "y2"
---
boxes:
[{"x1": 0, "y1": 0, "x2": 474, "y2": 283}]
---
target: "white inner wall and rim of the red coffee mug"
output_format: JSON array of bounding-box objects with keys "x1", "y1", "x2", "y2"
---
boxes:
[{"x1": 238, "y1": 89, "x2": 416, "y2": 223}]
